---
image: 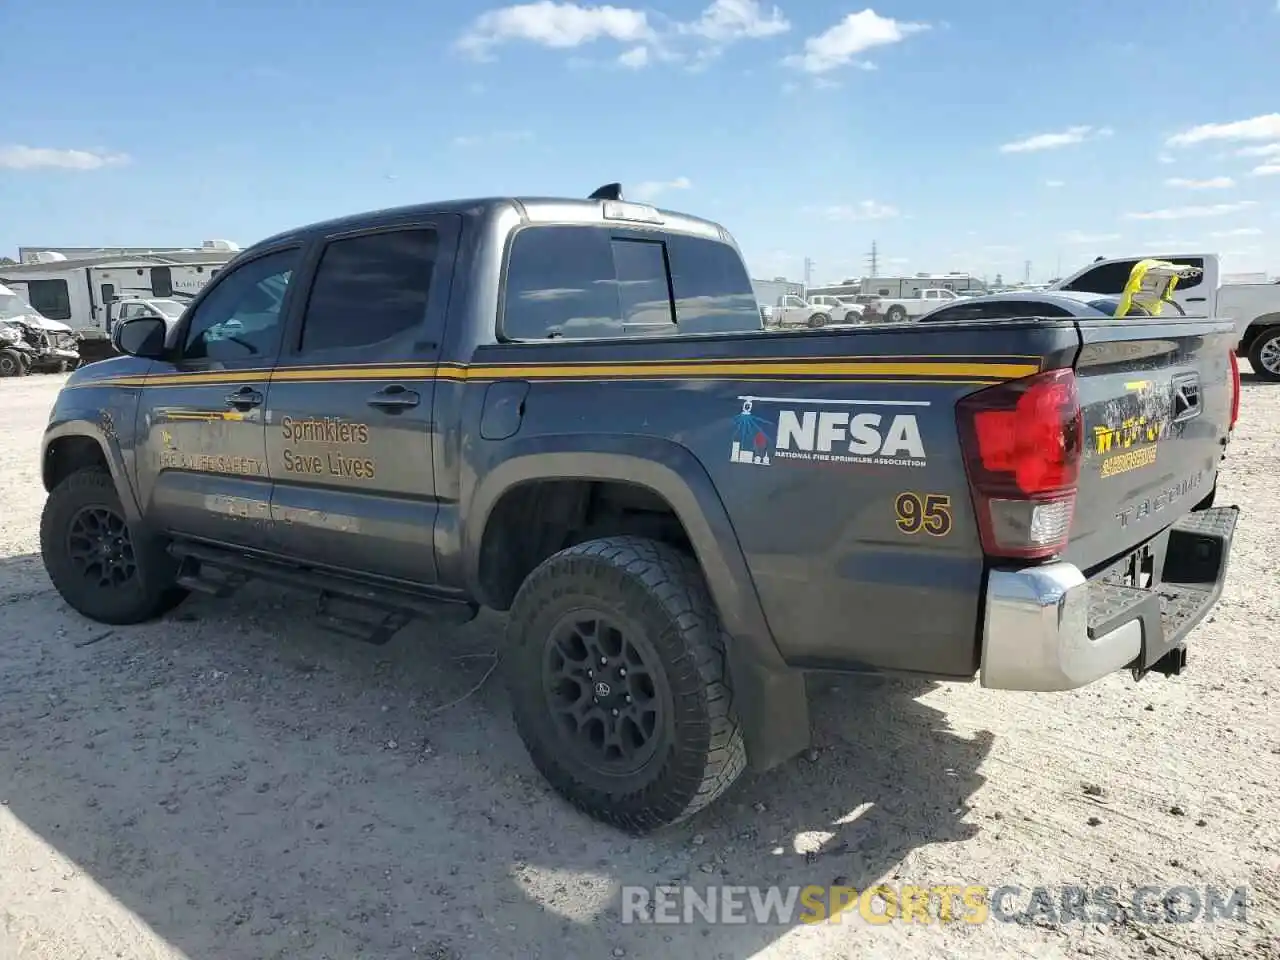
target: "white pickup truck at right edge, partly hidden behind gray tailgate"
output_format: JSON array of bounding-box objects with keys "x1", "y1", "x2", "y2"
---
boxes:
[{"x1": 1050, "y1": 253, "x2": 1280, "y2": 383}]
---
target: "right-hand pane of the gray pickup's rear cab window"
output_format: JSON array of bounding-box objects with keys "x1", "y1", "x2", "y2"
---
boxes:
[{"x1": 667, "y1": 234, "x2": 762, "y2": 333}]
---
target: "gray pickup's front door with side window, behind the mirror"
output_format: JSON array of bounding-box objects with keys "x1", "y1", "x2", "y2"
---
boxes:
[{"x1": 137, "y1": 247, "x2": 301, "y2": 548}]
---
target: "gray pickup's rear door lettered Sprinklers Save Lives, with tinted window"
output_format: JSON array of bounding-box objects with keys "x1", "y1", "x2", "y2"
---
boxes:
[{"x1": 266, "y1": 216, "x2": 461, "y2": 584}]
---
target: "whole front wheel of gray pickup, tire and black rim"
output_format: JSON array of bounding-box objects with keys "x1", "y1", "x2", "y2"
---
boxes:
[{"x1": 40, "y1": 470, "x2": 187, "y2": 625}]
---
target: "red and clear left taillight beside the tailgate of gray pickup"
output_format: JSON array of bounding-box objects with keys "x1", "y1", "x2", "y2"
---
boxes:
[{"x1": 956, "y1": 370, "x2": 1084, "y2": 559}]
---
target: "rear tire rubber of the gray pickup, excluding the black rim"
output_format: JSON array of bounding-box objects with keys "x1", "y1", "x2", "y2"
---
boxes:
[{"x1": 502, "y1": 536, "x2": 746, "y2": 835}]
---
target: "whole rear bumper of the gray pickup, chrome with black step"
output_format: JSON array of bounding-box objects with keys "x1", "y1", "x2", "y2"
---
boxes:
[{"x1": 980, "y1": 507, "x2": 1239, "y2": 691}]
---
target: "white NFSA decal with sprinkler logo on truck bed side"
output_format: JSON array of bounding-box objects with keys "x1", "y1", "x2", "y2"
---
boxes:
[{"x1": 728, "y1": 397, "x2": 929, "y2": 467}]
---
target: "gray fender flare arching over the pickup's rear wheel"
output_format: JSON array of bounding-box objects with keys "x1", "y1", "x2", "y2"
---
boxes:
[{"x1": 462, "y1": 434, "x2": 786, "y2": 669}]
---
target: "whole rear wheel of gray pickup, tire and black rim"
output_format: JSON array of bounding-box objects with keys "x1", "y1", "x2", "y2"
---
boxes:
[{"x1": 503, "y1": 536, "x2": 746, "y2": 833}]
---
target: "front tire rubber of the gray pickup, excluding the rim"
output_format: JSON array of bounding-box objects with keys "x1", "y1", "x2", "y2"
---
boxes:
[{"x1": 40, "y1": 468, "x2": 187, "y2": 626}]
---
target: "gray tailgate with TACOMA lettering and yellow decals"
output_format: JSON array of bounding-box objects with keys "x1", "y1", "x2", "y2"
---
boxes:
[{"x1": 1062, "y1": 317, "x2": 1235, "y2": 571}]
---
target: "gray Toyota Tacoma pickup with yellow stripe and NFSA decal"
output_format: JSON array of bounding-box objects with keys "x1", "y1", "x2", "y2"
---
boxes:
[{"x1": 41, "y1": 184, "x2": 1239, "y2": 832}]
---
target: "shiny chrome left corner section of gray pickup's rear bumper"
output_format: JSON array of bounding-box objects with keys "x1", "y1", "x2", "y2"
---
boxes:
[{"x1": 980, "y1": 562, "x2": 1143, "y2": 691}]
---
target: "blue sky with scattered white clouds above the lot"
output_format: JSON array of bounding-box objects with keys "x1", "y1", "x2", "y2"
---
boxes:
[{"x1": 0, "y1": 0, "x2": 1280, "y2": 283}]
